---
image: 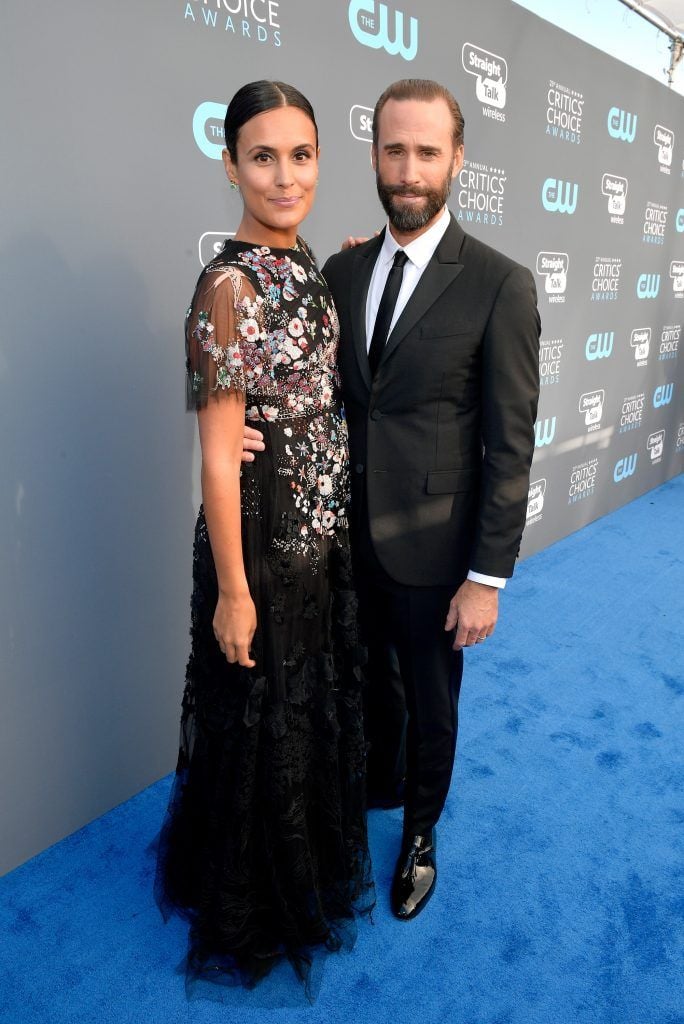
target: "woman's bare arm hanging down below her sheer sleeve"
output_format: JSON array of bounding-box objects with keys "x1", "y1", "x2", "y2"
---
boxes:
[{"x1": 198, "y1": 391, "x2": 256, "y2": 668}]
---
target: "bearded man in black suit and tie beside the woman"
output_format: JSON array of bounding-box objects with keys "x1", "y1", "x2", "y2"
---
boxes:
[{"x1": 245, "y1": 79, "x2": 540, "y2": 920}]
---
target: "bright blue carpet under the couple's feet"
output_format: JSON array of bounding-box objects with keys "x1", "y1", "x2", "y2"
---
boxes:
[{"x1": 0, "y1": 476, "x2": 684, "y2": 1024}]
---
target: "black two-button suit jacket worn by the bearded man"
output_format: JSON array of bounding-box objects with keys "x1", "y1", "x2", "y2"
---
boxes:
[{"x1": 323, "y1": 211, "x2": 540, "y2": 586}]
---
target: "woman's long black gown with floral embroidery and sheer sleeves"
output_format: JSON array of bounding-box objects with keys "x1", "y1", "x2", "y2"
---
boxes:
[{"x1": 156, "y1": 240, "x2": 374, "y2": 985}]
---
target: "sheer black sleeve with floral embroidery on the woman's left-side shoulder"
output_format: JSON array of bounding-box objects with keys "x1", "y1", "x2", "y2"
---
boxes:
[{"x1": 185, "y1": 266, "x2": 261, "y2": 410}]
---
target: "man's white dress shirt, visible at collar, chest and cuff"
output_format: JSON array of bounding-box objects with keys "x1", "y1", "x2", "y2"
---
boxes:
[{"x1": 366, "y1": 207, "x2": 506, "y2": 590}]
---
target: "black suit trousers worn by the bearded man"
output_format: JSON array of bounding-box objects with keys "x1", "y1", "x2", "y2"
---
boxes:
[{"x1": 353, "y1": 515, "x2": 463, "y2": 837}]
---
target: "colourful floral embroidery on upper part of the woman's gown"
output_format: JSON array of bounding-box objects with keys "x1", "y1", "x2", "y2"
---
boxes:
[{"x1": 186, "y1": 243, "x2": 349, "y2": 554}]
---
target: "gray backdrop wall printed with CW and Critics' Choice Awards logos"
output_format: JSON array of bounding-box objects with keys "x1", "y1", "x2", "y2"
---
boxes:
[{"x1": 0, "y1": 0, "x2": 684, "y2": 870}]
